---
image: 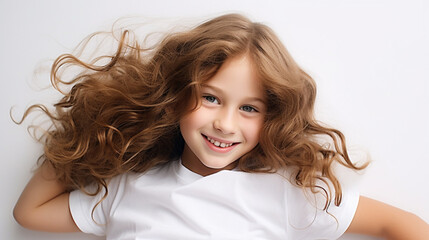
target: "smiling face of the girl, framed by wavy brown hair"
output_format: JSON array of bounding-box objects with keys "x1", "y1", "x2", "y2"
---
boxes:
[{"x1": 180, "y1": 55, "x2": 266, "y2": 176}]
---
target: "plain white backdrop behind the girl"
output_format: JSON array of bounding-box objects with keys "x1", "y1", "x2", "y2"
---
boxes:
[{"x1": 0, "y1": 0, "x2": 429, "y2": 240}]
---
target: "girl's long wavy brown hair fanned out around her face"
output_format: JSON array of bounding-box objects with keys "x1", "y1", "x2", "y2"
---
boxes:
[{"x1": 17, "y1": 14, "x2": 365, "y2": 209}]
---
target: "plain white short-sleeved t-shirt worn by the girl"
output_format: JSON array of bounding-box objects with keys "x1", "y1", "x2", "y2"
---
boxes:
[{"x1": 69, "y1": 158, "x2": 359, "y2": 240}]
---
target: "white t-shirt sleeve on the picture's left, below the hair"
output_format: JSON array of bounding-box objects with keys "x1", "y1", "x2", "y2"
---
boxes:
[{"x1": 69, "y1": 176, "x2": 123, "y2": 236}]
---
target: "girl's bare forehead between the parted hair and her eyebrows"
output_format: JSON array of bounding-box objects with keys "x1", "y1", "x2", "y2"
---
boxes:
[{"x1": 203, "y1": 55, "x2": 265, "y2": 99}]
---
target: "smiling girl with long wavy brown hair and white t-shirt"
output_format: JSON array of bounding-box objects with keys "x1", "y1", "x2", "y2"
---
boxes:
[{"x1": 14, "y1": 14, "x2": 429, "y2": 240}]
